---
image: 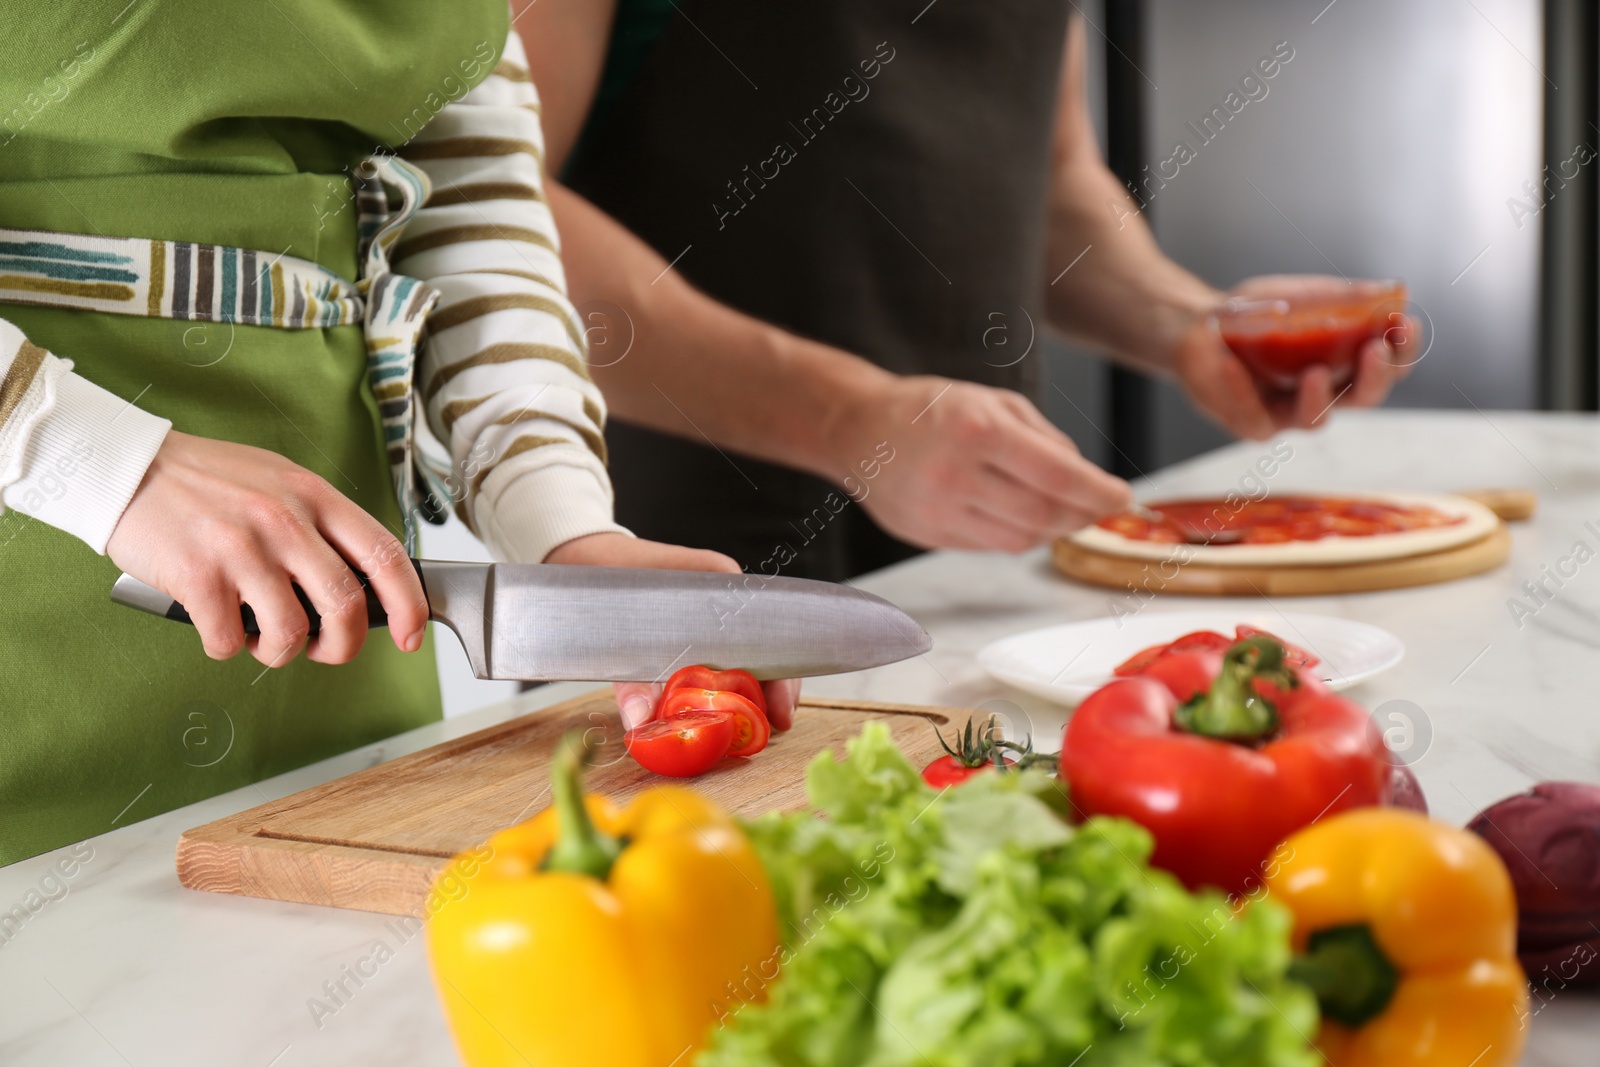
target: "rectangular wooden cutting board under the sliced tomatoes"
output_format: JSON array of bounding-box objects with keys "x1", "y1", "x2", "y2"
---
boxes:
[{"x1": 178, "y1": 689, "x2": 947, "y2": 917}]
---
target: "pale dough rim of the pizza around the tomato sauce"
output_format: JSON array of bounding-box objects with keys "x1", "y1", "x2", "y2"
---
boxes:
[{"x1": 1067, "y1": 491, "x2": 1499, "y2": 566}]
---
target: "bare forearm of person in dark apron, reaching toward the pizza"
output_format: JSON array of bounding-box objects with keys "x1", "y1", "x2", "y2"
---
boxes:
[{"x1": 549, "y1": 181, "x2": 891, "y2": 478}]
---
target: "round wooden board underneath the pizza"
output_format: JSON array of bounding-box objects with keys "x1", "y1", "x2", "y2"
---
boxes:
[{"x1": 1053, "y1": 522, "x2": 1510, "y2": 597}]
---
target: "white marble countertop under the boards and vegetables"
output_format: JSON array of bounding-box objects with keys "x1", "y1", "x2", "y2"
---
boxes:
[{"x1": 0, "y1": 411, "x2": 1600, "y2": 1067}]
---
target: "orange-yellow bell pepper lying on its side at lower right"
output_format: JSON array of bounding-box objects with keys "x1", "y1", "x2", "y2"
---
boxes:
[{"x1": 1266, "y1": 808, "x2": 1528, "y2": 1067}]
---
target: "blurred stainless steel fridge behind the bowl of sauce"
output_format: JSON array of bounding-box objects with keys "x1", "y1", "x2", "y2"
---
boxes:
[{"x1": 1046, "y1": 0, "x2": 1542, "y2": 467}]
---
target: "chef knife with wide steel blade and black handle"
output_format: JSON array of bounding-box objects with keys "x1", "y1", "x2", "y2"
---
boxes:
[{"x1": 110, "y1": 560, "x2": 933, "y2": 681}]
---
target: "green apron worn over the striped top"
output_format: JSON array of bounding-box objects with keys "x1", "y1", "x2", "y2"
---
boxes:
[{"x1": 0, "y1": 0, "x2": 507, "y2": 864}]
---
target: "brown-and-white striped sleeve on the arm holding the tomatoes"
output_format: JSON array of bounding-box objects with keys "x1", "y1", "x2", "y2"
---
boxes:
[{"x1": 394, "y1": 30, "x2": 626, "y2": 563}]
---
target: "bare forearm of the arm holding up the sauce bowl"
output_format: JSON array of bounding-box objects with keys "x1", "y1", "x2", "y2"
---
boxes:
[{"x1": 1048, "y1": 158, "x2": 1219, "y2": 371}]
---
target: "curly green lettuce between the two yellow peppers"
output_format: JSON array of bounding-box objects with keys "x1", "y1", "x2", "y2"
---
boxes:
[{"x1": 696, "y1": 723, "x2": 1320, "y2": 1067}]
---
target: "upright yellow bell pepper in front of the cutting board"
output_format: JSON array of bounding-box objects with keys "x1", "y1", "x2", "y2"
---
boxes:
[{"x1": 427, "y1": 739, "x2": 779, "y2": 1067}]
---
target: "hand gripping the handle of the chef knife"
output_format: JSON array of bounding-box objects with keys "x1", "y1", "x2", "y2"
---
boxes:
[{"x1": 106, "y1": 430, "x2": 429, "y2": 667}]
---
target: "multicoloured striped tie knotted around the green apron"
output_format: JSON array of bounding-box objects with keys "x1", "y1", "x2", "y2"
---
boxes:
[{"x1": 0, "y1": 155, "x2": 451, "y2": 553}]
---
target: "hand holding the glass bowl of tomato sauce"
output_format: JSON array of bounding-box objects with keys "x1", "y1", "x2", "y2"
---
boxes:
[{"x1": 1171, "y1": 275, "x2": 1422, "y2": 440}]
